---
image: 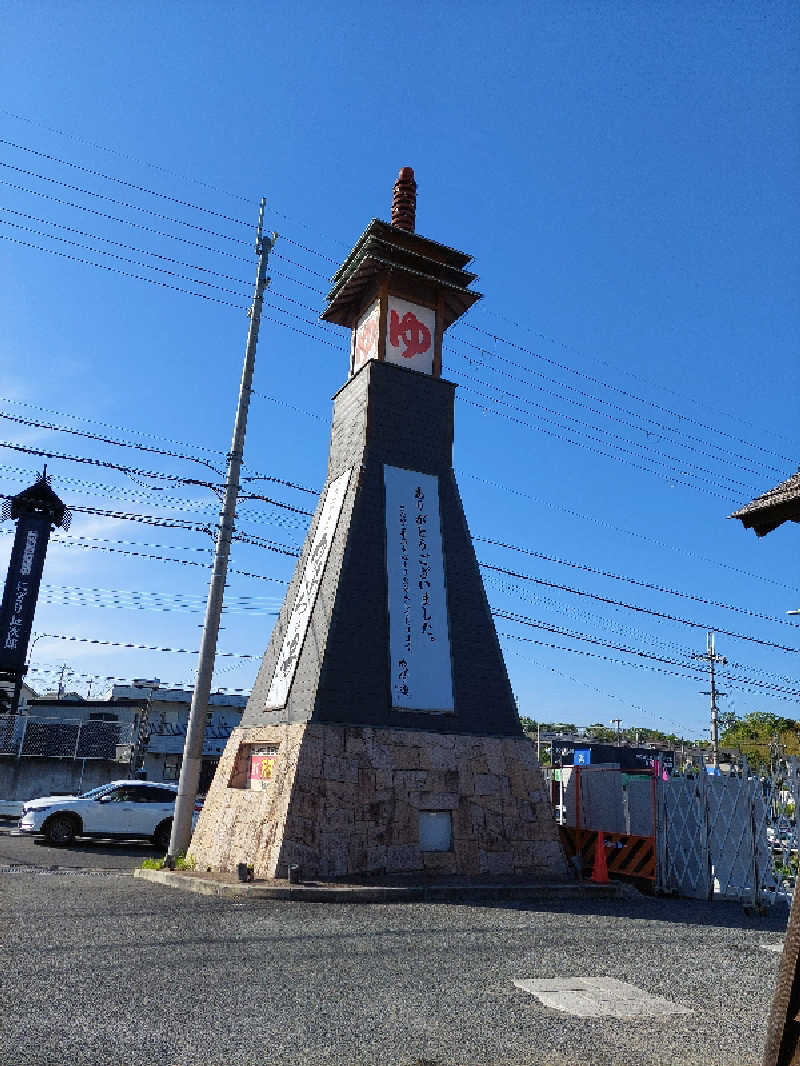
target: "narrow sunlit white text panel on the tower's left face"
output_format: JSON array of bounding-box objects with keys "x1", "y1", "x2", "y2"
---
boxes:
[{"x1": 266, "y1": 470, "x2": 351, "y2": 710}]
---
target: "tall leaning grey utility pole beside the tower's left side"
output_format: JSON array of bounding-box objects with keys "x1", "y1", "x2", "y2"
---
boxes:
[{"x1": 166, "y1": 197, "x2": 277, "y2": 869}]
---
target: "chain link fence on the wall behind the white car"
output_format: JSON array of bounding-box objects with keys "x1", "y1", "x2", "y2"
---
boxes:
[{"x1": 0, "y1": 714, "x2": 134, "y2": 759}]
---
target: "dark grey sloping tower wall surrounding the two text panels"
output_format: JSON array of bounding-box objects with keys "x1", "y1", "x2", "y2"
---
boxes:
[{"x1": 242, "y1": 360, "x2": 522, "y2": 737}]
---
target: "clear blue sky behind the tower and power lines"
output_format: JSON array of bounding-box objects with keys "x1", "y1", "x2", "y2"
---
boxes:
[{"x1": 0, "y1": 2, "x2": 800, "y2": 737}]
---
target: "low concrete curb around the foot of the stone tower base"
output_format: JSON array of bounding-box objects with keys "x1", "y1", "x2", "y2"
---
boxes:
[{"x1": 133, "y1": 869, "x2": 627, "y2": 903}]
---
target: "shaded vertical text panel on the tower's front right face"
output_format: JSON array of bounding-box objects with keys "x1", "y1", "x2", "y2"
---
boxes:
[{"x1": 383, "y1": 466, "x2": 453, "y2": 712}]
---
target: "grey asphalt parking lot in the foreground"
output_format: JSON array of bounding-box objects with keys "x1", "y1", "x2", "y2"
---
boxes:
[{"x1": 0, "y1": 833, "x2": 787, "y2": 1066}]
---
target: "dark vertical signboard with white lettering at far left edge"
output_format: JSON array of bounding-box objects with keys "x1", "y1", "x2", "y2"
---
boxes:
[{"x1": 0, "y1": 515, "x2": 50, "y2": 672}]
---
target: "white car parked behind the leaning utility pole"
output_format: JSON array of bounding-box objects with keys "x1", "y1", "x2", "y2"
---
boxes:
[{"x1": 18, "y1": 780, "x2": 203, "y2": 851}]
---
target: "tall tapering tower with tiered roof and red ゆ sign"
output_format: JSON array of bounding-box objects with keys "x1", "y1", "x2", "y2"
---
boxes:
[{"x1": 190, "y1": 167, "x2": 569, "y2": 879}]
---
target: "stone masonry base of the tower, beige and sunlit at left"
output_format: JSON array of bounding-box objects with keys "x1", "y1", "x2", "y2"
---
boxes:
[{"x1": 189, "y1": 724, "x2": 572, "y2": 882}]
